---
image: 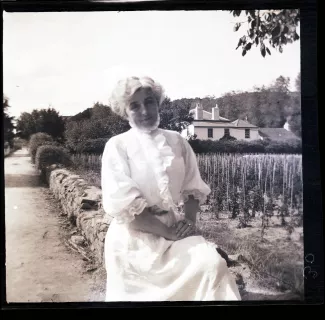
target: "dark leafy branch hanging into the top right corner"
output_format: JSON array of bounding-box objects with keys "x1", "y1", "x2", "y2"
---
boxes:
[{"x1": 230, "y1": 9, "x2": 300, "y2": 57}]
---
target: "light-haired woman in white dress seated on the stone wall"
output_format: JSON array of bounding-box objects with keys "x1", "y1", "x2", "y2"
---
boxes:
[{"x1": 102, "y1": 77, "x2": 241, "y2": 301}]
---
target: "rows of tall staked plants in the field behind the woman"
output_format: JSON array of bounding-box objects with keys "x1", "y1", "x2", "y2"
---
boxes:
[{"x1": 72, "y1": 153, "x2": 303, "y2": 230}]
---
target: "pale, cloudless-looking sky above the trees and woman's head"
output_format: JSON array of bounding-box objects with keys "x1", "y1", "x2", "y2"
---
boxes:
[{"x1": 3, "y1": 11, "x2": 300, "y2": 117}]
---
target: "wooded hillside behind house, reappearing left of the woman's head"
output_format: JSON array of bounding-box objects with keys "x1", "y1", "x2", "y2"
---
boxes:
[{"x1": 67, "y1": 89, "x2": 301, "y2": 136}]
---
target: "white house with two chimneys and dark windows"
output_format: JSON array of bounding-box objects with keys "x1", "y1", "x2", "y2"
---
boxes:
[{"x1": 181, "y1": 103, "x2": 259, "y2": 141}]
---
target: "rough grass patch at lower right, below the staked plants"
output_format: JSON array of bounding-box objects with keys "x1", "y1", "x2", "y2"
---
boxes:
[{"x1": 198, "y1": 212, "x2": 304, "y2": 298}]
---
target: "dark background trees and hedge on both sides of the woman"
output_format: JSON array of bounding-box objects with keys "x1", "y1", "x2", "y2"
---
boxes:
[{"x1": 17, "y1": 76, "x2": 301, "y2": 153}]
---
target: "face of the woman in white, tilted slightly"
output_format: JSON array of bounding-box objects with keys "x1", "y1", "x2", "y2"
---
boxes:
[{"x1": 126, "y1": 88, "x2": 158, "y2": 129}]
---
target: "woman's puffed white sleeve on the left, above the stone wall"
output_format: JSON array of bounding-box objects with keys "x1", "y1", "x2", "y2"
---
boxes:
[{"x1": 101, "y1": 137, "x2": 147, "y2": 223}]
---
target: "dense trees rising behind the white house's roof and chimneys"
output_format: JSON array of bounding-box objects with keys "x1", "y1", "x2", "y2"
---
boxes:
[{"x1": 175, "y1": 74, "x2": 301, "y2": 137}]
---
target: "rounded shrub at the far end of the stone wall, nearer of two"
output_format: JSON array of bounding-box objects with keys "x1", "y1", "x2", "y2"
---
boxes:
[{"x1": 35, "y1": 145, "x2": 72, "y2": 172}]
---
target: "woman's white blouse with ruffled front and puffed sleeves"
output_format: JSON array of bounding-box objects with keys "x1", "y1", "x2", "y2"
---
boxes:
[{"x1": 101, "y1": 128, "x2": 211, "y2": 223}]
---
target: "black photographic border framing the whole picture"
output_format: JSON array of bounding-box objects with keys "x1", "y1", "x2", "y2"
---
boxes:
[{"x1": 1, "y1": 0, "x2": 324, "y2": 309}]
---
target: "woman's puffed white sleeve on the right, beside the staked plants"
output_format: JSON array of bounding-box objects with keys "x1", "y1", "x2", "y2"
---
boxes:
[{"x1": 181, "y1": 137, "x2": 211, "y2": 204}]
